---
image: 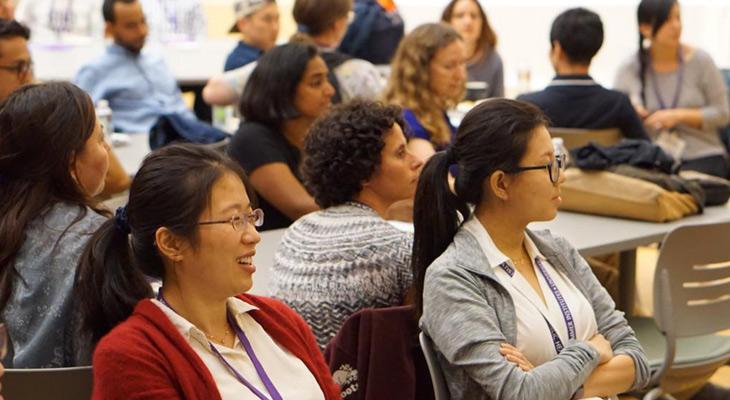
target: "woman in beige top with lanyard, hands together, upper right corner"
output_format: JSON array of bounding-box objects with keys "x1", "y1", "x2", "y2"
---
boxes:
[{"x1": 615, "y1": 0, "x2": 730, "y2": 177}]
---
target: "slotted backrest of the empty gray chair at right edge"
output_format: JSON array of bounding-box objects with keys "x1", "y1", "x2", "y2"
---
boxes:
[{"x1": 654, "y1": 222, "x2": 730, "y2": 338}]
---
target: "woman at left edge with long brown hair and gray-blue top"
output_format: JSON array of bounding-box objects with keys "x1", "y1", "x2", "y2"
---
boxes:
[{"x1": 0, "y1": 83, "x2": 109, "y2": 368}]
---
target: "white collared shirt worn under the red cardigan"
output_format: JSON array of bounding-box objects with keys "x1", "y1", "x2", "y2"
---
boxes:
[{"x1": 152, "y1": 297, "x2": 325, "y2": 400}]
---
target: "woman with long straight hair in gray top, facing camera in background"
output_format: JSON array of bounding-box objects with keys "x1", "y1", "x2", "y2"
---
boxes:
[{"x1": 441, "y1": 0, "x2": 504, "y2": 100}]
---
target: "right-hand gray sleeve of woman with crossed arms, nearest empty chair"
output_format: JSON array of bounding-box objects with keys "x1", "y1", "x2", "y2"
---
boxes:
[{"x1": 556, "y1": 234, "x2": 651, "y2": 389}]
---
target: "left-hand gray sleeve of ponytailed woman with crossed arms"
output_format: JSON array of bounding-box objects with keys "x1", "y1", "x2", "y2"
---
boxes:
[{"x1": 421, "y1": 257, "x2": 599, "y2": 400}]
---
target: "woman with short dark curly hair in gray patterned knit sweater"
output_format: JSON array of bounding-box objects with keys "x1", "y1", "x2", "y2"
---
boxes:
[{"x1": 272, "y1": 100, "x2": 421, "y2": 347}]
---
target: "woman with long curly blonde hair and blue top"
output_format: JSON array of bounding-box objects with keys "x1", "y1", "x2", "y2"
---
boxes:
[{"x1": 385, "y1": 24, "x2": 466, "y2": 160}]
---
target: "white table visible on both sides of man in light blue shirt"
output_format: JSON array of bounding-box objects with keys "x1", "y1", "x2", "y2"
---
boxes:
[{"x1": 30, "y1": 39, "x2": 237, "y2": 85}]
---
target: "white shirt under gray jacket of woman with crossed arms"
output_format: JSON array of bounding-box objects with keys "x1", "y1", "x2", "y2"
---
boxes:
[{"x1": 463, "y1": 217, "x2": 598, "y2": 366}]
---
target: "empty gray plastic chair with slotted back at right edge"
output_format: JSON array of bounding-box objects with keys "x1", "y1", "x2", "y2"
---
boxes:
[{"x1": 629, "y1": 222, "x2": 730, "y2": 400}]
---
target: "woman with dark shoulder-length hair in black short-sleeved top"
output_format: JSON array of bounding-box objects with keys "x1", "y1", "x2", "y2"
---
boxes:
[{"x1": 228, "y1": 43, "x2": 334, "y2": 230}]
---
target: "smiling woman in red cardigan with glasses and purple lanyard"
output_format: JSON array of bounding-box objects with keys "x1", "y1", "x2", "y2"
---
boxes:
[{"x1": 77, "y1": 144, "x2": 340, "y2": 400}]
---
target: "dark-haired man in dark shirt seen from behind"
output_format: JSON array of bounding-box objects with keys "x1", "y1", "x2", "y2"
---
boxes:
[{"x1": 518, "y1": 8, "x2": 649, "y2": 140}]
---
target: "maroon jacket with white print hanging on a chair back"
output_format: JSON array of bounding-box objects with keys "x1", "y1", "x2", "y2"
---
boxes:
[{"x1": 325, "y1": 306, "x2": 434, "y2": 400}]
